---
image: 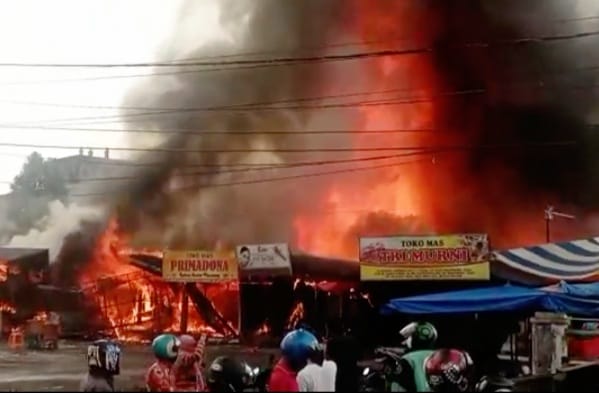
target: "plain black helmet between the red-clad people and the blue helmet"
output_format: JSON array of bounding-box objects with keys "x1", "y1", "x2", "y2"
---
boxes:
[{"x1": 206, "y1": 356, "x2": 249, "y2": 392}]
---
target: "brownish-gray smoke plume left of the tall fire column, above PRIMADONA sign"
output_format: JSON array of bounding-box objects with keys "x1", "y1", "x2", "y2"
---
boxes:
[{"x1": 119, "y1": 0, "x2": 353, "y2": 247}]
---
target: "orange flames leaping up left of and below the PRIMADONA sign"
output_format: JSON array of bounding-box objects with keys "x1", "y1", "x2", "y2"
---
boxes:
[{"x1": 79, "y1": 219, "x2": 237, "y2": 340}]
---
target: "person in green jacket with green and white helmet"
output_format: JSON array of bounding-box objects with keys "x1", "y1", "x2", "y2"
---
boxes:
[{"x1": 394, "y1": 322, "x2": 438, "y2": 392}]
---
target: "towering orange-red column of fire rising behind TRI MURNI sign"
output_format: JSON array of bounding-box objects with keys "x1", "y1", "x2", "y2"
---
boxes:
[{"x1": 294, "y1": 1, "x2": 564, "y2": 259}]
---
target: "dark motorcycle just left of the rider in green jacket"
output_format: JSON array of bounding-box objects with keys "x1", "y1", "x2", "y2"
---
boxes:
[{"x1": 360, "y1": 347, "x2": 405, "y2": 392}]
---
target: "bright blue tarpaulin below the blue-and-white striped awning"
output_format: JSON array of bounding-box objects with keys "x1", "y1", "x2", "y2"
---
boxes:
[{"x1": 381, "y1": 283, "x2": 599, "y2": 316}]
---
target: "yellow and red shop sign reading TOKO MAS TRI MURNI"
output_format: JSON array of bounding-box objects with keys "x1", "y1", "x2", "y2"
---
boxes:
[{"x1": 360, "y1": 234, "x2": 490, "y2": 281}]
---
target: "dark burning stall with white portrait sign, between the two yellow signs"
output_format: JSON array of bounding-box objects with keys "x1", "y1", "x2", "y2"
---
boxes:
[{"x1": 237, "y1": 244, "x2": 359, "y2": 338}]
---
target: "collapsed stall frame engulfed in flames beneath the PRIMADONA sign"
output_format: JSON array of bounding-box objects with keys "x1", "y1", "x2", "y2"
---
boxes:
[{"x1": 84, "y1": 254, "x2": 238, "y2": 339}]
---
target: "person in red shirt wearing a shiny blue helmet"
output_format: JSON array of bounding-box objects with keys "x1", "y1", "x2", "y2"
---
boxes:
[{"x1": 267, "y1": 329, "x2": 318, "y2": 392}]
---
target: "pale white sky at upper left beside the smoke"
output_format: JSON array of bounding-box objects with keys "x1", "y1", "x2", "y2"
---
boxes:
[{"x1": 0, "y1": 0, "x2": 225, "y2": 194}]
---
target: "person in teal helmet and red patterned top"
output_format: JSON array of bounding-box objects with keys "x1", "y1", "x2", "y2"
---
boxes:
[{"x1": 146, "y1": 334, "x2": 181, "y2": 392}]
